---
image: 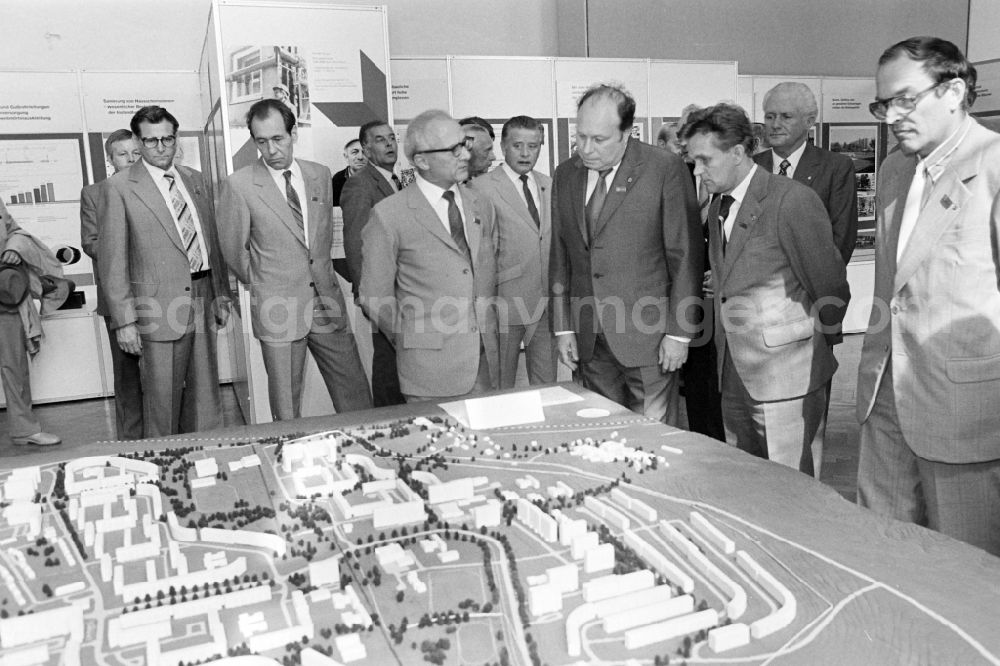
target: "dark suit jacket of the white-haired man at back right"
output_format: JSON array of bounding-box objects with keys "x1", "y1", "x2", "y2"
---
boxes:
[{"x1": 753, "y1": 143, "x2": 858, "y2": 265}]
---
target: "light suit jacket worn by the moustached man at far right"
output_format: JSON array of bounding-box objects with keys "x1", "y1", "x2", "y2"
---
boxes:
[{"x1": 857, "y1": 120, "x2": 1000, "y2": 463}]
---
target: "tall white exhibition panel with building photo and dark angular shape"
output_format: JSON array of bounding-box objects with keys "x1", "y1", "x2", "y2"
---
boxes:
[{"x1": 213, "y1": 0, "x2": 392, "y2": 423}]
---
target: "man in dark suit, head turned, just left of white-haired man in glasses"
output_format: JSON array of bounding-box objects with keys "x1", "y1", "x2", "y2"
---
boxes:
[{"x1": 340, "y1": 120, "x2": 404, "y2": 407}]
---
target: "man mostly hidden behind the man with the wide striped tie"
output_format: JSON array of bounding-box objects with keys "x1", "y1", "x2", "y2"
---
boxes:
[{"x1": 80, "y1": 129, "x2": 142, "y2": 439}]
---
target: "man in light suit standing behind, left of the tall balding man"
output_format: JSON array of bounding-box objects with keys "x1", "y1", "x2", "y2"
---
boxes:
[{"x1": 471, "y1": 116, "x2": 556, "y2": 388}]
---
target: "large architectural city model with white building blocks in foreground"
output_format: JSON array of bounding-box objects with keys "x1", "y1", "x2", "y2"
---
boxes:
[{"x1": 0, "y1": 385, "x2": 1000, "y2": 666}]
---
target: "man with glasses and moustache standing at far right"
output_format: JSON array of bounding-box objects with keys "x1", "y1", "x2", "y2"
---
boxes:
[{"x1": 857, "y1": 37, "x2": 1000, "y2": 555}]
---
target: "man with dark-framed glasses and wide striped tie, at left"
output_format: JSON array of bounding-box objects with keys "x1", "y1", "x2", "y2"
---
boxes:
[{"x1": 97, "y1": 106, "x2": 231, "y2": 437}]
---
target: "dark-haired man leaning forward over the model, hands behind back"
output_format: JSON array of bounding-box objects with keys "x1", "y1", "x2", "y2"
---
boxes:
[{"x1": 682, "y1": 104, "x2": 850, "y2": 476}]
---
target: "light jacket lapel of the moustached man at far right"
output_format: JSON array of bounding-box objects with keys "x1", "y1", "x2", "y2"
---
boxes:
[{"x1": 892, "y1": 157, "x2": 979, "y2": 291}]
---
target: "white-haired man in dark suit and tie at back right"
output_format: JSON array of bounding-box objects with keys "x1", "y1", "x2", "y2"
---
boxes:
[{"x1": 753, "y1": 81, "x2": 858, "y2": 266}]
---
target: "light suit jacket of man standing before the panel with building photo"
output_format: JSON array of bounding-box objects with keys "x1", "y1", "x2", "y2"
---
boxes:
[{"x1": 219, "y1": 159, "x2": 350, "y2": 342}]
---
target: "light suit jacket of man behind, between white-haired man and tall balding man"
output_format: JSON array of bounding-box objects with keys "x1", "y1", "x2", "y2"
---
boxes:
[{"x1": 471, "y1": 167, "x2": 552, "y2": 325}]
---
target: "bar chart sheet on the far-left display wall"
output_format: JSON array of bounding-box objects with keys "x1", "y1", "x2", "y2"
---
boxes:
[{"x1": 0, "y1": 137, "x2": 83, "y2": 207}]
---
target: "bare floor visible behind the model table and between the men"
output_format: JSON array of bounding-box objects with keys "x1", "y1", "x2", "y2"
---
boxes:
[{"x1": 0, "y1": 335, "x2": 862, "y2": 501}]
